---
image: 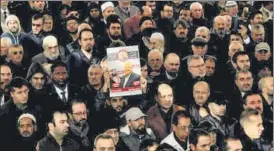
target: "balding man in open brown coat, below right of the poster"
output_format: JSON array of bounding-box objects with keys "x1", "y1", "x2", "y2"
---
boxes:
[{"x1": 147, "y1": 84, "x2": 185, "y2": 140}]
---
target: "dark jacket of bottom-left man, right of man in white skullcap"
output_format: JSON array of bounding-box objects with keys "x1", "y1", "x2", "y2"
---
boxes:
[{"x1": 38, "y1": 133, "x2": 80, "y2": 151}]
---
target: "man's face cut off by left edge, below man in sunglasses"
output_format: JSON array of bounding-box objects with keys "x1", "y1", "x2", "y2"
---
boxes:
[{"x1": 0, "y1": 65, "x2": 12, "y2": 90}]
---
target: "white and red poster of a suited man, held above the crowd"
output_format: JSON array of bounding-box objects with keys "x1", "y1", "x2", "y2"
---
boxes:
[{"x1": 107, "y1": 46, "x2": 142, "y2": 97}]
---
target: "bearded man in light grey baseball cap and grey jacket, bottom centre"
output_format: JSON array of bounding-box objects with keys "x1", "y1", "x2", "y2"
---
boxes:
[{"x1": 120, "y1": 107, "x2": 155, "y2": 151}]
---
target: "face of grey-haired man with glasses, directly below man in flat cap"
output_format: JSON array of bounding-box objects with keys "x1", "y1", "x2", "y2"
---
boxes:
[{"x1": 188, "y1": 58, "x2": 206, "y2": 77}]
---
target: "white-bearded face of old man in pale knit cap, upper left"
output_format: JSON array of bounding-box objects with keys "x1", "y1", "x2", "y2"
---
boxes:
[{"x1": 44, "y1": 42, "x2": 59, "y2": 60}]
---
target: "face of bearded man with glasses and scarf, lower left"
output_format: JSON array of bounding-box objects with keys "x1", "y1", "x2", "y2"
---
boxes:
[{"x1": 72, "y1": 103, "x2": 88, "y2": 123}]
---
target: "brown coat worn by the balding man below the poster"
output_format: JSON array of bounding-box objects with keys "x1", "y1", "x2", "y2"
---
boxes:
[{"x1": 147, "y1": 104, "x2": 185, "y2": 140}]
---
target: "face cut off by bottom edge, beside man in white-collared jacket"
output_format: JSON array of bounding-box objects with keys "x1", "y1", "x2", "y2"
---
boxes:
[{"x1": 191, "y1": 136, "x2": 211, "y2": 151}]
